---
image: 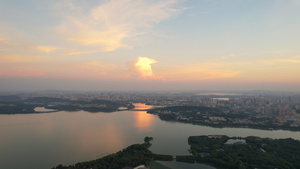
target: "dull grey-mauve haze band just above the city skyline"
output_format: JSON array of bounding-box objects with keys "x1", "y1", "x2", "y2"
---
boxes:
[{"x1": 0, "y1": 78, "x2": 300, "y2": 93}]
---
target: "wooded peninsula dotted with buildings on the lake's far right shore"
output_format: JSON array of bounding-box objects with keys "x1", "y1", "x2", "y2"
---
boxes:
[{"x1": 147, "y1": 106, "x2": 300, "y2": 131}]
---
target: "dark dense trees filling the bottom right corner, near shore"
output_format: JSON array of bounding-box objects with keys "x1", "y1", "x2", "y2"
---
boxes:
[{"x1": 189, "y1": 136, "x2": 300, "y2": 169}]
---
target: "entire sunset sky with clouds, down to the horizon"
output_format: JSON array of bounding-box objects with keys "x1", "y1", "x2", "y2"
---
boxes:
[{"x1": 0, "y1": 0, "x2": 300, "y2": 91}]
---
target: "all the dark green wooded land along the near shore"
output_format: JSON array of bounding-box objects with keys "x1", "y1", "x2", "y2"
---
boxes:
[{"x1": 53, "y1": 135, "x2": 300, "y2": 169}]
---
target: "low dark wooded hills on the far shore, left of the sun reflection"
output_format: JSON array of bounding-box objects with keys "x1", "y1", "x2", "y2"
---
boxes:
[{"x1": 0, "y1": 96, "x2": 134, "y2": 114}]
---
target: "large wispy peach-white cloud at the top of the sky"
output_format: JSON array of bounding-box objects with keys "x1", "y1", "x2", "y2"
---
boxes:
[{"x1": 56, "y1": 0, "x2": 182, "y2": 51}]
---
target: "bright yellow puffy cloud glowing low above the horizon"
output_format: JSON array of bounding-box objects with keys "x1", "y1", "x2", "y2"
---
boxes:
[{"x1": 135, "y1": 57, "x2": 157, "y2": 79}]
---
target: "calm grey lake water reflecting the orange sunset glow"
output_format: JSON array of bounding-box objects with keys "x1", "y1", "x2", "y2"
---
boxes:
[{"x1": 0, "y1": 103, "x2": 300, "y2": 169}]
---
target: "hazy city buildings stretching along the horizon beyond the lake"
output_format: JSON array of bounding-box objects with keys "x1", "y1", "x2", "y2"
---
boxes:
[{"x1": 2, "y1": 91, "x2": 300, "y2": 127}]
